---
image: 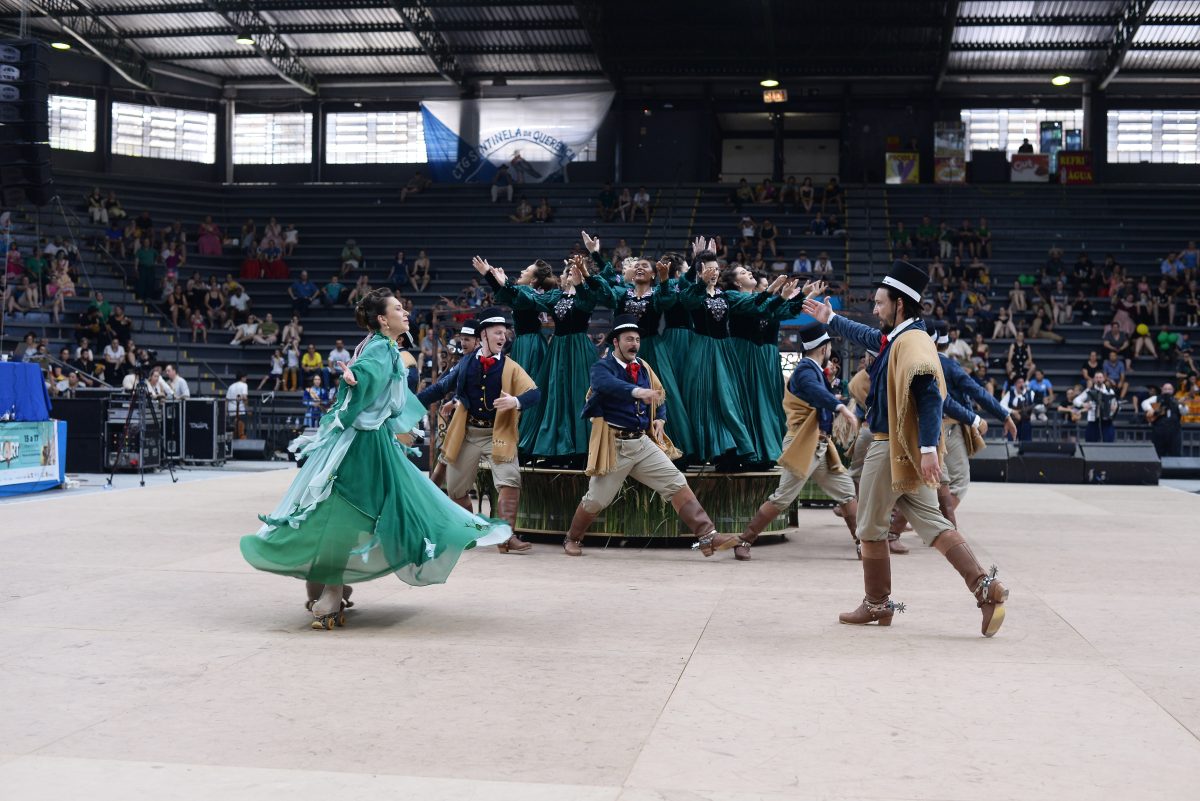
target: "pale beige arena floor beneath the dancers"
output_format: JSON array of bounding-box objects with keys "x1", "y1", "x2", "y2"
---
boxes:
[{"x1": 0, "y1": 470, "x2": 1200, "y2": 801}]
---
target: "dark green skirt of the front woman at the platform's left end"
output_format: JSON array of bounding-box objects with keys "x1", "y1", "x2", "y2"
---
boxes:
[{"x1": 522, "y1": 332, "x2": 596, "y2": 457}]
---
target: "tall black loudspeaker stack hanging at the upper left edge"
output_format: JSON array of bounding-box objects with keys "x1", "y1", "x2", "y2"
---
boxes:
[{"x1": 0, "y1": 40, "x2": 53, "y2": 206}]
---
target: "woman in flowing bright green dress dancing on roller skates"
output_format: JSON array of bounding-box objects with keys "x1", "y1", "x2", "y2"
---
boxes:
[{"x1": 241, "y1": 289, "x2": 512, "y2": 630}]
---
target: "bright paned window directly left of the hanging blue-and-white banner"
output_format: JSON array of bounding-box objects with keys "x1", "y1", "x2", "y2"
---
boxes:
[{"x1": 325, "y1": 112, "x2": 426, "y2": 164}]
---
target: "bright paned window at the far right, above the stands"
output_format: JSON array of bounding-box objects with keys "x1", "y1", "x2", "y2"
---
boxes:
[{"x1": 1108, "y1": 109, "x2": 1200, "y2": 164}]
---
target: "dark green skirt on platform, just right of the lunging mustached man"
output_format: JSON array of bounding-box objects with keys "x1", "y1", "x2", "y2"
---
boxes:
[{"x1": 680, "y1": 335, "x2": 754, "y2": 462}]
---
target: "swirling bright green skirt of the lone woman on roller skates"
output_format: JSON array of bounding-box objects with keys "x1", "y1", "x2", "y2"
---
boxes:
[{"x1": 241, "y1": 427, "x2": 511, "y2": 586}]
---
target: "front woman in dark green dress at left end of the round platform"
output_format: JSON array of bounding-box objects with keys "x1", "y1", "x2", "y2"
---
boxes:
[{"x1": 476, "y1": 250, "x2": 598, "y2": 466}]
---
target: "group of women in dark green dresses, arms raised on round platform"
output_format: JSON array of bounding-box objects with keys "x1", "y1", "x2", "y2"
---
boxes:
[{"x1": 473, "y1": 233, "x2": 803, "y2": 470}]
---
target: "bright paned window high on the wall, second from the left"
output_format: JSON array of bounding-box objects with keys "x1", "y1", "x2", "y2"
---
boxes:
[{"x1": 113, "y1": 103, "x2": 217, "y2": 164}]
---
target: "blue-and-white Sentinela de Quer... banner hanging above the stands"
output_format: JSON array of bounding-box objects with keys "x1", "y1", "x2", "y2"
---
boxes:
[{"x1": 421, "y1": 91, "x2": 616, "y2": 183}]
